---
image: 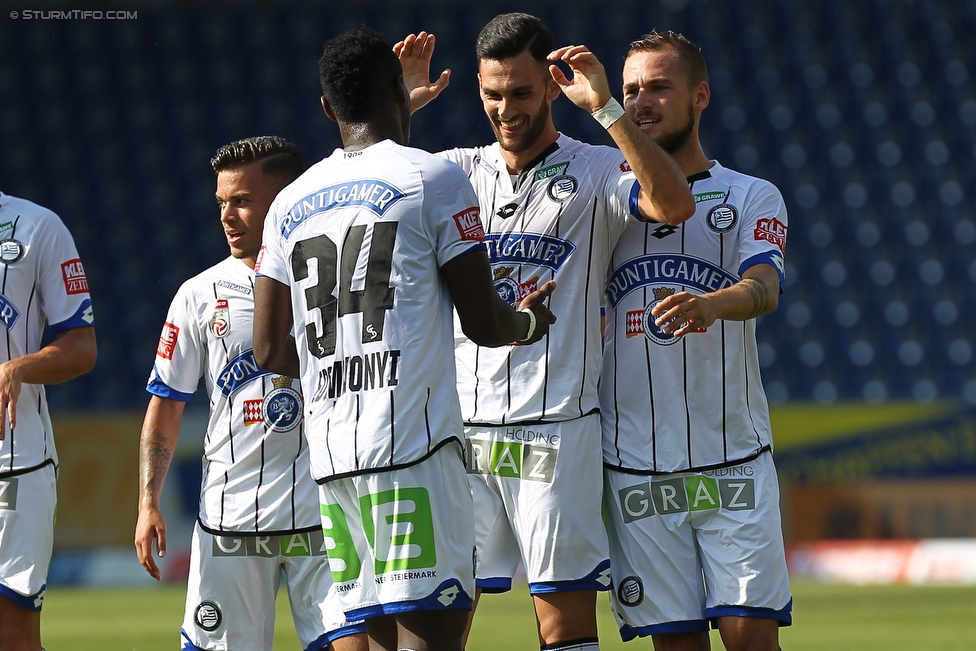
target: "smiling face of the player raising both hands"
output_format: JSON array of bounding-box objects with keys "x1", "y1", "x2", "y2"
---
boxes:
[{"x1": 478, "y1": 51, "x2": 559, "y2": 172}]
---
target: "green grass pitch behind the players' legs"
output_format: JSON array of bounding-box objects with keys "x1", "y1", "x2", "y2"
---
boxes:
[{"x1": 42, "y1": 583, "x2": 976, "y2": 651}]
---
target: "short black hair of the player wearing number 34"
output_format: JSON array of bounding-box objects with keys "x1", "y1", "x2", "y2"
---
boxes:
[{"x1": 319, "y1": 25, "x2": 403, "y2": 124}]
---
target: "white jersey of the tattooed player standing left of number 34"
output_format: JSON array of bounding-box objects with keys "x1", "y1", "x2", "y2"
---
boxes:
[{"x1": 147, "y1": 257, "x2": 321, "y2": 534}]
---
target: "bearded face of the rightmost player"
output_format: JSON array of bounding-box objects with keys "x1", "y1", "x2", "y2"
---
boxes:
[{"x1": 623, "y1": 48, "x2": 708, "y2": 155}]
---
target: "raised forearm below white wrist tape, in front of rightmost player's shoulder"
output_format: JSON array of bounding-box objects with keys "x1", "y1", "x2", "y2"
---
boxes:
[{"x1": 607, "y1": 116, "x2": 695, "y2": 225}]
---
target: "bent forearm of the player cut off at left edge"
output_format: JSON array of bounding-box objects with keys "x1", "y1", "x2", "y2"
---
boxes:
[{"x1": 4, "y1": 326, "x2": 98, "y2": 384}]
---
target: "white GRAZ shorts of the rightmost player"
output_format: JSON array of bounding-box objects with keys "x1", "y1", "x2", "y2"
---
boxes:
[{"x1": 604, "y1": 452, "x2": 793, "y2": 641}]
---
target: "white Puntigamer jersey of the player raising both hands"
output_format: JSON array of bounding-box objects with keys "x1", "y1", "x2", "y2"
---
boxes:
[{"x1": 440, "y1": 135, "x2": 640, "y2": 425}]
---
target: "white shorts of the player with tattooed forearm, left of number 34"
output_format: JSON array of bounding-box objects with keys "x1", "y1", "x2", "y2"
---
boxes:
[{"x1": 181, "y1": 522, "x2": 366, "y2": 651}]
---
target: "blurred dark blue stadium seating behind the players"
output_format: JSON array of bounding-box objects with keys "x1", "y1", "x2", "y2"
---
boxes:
[{"x1": 0, "y1": 0, "x2": 976, "y2": 409}]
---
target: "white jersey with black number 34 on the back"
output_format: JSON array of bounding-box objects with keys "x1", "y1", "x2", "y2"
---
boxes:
[{"x1": 257, "y1": 140, "x2": 484, "y2": 481}]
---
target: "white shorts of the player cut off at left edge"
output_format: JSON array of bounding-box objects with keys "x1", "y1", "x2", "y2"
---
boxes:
[{"x1": 0, "y1": 464, "x2": 58, "y2": 611}]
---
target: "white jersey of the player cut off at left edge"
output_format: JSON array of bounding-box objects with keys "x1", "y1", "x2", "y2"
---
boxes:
[{"x1": 0, "y1": 193, "x2": 94, "y2": 477}]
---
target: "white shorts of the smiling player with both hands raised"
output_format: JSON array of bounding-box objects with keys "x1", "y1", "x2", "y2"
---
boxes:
[{"x1": 465, "y1": 414, "x2": 610, "y2": 594}]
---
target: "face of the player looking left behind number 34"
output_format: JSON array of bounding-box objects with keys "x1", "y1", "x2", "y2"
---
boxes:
[{"x1": 216, "y1": 161, "x2": 280, "y2": 269}]
